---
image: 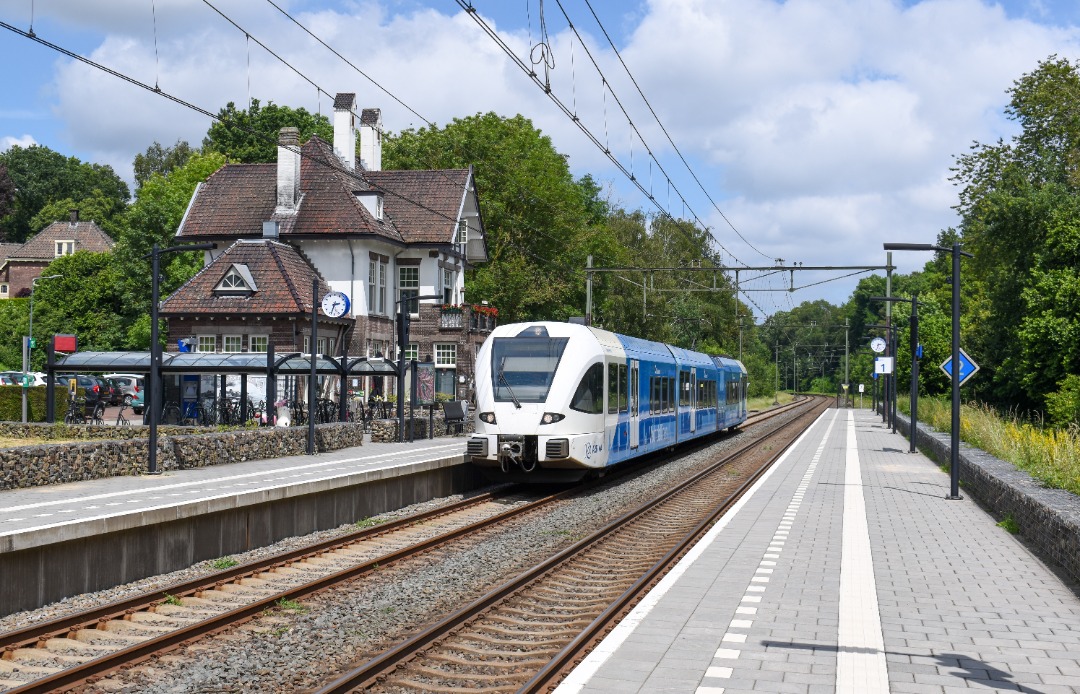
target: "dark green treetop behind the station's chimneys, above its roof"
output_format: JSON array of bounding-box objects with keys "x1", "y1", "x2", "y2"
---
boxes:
[{"x1": 202, "y1": 99, "x2": 334, "y2": 164}]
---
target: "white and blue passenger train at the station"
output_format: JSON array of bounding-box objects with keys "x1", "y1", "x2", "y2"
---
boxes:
[{"x1": 467, "y1": 322, "x2": 747, "y2": 481}]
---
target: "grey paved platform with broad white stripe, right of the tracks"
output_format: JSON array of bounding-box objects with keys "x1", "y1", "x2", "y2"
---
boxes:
[{"x1": 557, "y1": 409, "x2": 1080, "y2": 694}]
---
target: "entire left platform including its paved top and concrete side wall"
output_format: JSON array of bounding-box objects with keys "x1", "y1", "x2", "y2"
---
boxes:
[{"x1": 0, "y1": 437, "x2": 481, "y2": 614}]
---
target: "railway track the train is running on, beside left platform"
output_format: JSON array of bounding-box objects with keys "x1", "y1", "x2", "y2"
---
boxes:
[{"x1": 0, "y1": 397, "x2": 812, "y2": 694}]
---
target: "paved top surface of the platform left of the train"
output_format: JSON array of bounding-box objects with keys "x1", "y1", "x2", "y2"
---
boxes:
[{"x1": 0, "y1": 437, "x2": 467, "y2": 553}]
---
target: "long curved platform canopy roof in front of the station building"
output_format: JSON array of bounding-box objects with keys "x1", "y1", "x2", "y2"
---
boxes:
[{"x1": 52, "y1": 352, "x2": 397, "y2": 376}]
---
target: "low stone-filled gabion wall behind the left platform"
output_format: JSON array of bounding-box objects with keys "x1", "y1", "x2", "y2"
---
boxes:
[{"x1": 0, "y1": 422, "x2": 367, "y2": 489}]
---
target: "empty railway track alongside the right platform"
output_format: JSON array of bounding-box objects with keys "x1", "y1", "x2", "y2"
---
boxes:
[{"x1": 319, "y1": 400, "x2": 827, "y2": 694}]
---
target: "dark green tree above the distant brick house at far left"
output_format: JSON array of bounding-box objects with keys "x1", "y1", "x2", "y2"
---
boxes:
[{"x1": 0, "y1": 145, "x2": 131, "y2": 243}]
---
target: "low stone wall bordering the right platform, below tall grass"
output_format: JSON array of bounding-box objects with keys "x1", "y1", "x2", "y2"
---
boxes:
[{"x1": 896, "y1": 412, "x2": 1080, "y2": 583}]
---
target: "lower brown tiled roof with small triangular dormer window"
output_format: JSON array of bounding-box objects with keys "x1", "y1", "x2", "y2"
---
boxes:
[{"x1": 161, "y1": 239, "x2": 330, "y2": 316}]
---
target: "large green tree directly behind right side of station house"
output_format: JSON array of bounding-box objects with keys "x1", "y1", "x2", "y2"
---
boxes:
[{"x1": 383, "y1": 113, "x2": 612, "y2": 321}]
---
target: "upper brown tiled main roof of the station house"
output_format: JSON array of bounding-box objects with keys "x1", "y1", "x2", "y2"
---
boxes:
[{"x1": 177, "y1": 137, "x2": 469, "y2": 244}]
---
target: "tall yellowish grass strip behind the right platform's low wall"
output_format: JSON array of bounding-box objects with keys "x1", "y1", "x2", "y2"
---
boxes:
[{"x1": 897, "y1": 397, "x2": 1080, "y2": 494}]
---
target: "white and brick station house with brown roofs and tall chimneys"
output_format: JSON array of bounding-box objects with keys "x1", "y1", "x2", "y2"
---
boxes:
[{"x1": 161, "y1": 94, "x2": 495, "y2": 397}]
